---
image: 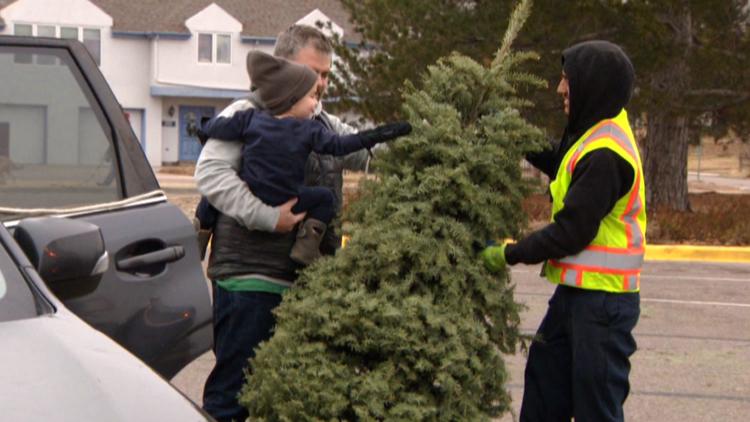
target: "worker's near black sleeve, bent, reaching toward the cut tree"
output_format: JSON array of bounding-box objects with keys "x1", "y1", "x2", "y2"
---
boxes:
[{"x1": 505, "y1": 149, "x2": 634, "y2": 265}]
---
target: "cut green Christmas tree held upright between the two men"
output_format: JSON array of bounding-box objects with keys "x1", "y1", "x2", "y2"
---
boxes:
[{"x1": 240, "y1": 0, "x2": 543, "y2": 421}]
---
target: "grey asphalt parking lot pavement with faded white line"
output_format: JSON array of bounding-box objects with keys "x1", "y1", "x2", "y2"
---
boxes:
[{"x1": 172, "y1": 262, "x2": 750, "y2": 422}]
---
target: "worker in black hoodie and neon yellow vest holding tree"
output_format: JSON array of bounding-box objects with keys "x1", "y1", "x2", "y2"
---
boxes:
[{"x1": 482, "y1": 41, "x2": 646, "y2": 422}]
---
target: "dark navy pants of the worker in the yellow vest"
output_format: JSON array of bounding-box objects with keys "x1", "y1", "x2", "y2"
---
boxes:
[{"x1": 521, "y1": 285, "x2": 640, "y2": 422}]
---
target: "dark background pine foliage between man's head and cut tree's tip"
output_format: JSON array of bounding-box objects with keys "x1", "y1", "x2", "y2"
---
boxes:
[{"x1": 326, "y1": 0, "x2": 515, "y2": 121}]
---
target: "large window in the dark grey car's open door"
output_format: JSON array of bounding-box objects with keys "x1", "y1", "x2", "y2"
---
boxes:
[{"x1": 0, "y1": 47, "x2": 121, "y2": 219}]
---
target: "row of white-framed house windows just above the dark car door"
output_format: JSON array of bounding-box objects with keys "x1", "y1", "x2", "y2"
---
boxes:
[{"x1": 13, "y1": 23, "x2": 102, "y2": 66}]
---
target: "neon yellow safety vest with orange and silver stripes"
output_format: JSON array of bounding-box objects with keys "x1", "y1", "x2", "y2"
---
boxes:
[{"x1": 544, "y1": 109, "x2": 646, "y2": 293}]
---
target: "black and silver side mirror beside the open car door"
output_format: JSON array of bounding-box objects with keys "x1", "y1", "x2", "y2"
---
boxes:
[{"x1": 13, "y1": 217, "x2": 109, "y2": 287}]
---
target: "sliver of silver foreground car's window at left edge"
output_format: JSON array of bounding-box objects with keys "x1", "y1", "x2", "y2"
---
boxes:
[{"x1": 0, "y1": 244, "x2": 37, "y2": 322}]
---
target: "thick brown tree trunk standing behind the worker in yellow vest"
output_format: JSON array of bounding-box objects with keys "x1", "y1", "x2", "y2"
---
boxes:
[{"x1": 643, "y1": 111, "x2": 690, "y2": 211}]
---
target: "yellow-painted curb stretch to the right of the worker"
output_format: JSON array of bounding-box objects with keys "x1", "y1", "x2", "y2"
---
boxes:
[{"x1": 645, "y1": 245, "x2": 750, "y2": 264}]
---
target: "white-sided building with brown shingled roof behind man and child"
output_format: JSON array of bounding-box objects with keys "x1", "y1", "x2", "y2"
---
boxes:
[{"x1": 0, "y1": 0, "x2": 357, "y2": 167}]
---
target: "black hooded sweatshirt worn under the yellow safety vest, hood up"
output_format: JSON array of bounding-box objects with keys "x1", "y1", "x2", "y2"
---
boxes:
[{"x1": 505, "y1": 41, "x2": 635, "y2": 265}]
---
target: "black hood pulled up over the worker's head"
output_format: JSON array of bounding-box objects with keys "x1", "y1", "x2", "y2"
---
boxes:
[{"x1": 562, "y1": 41, "x2": 635, "y2": 139}]
